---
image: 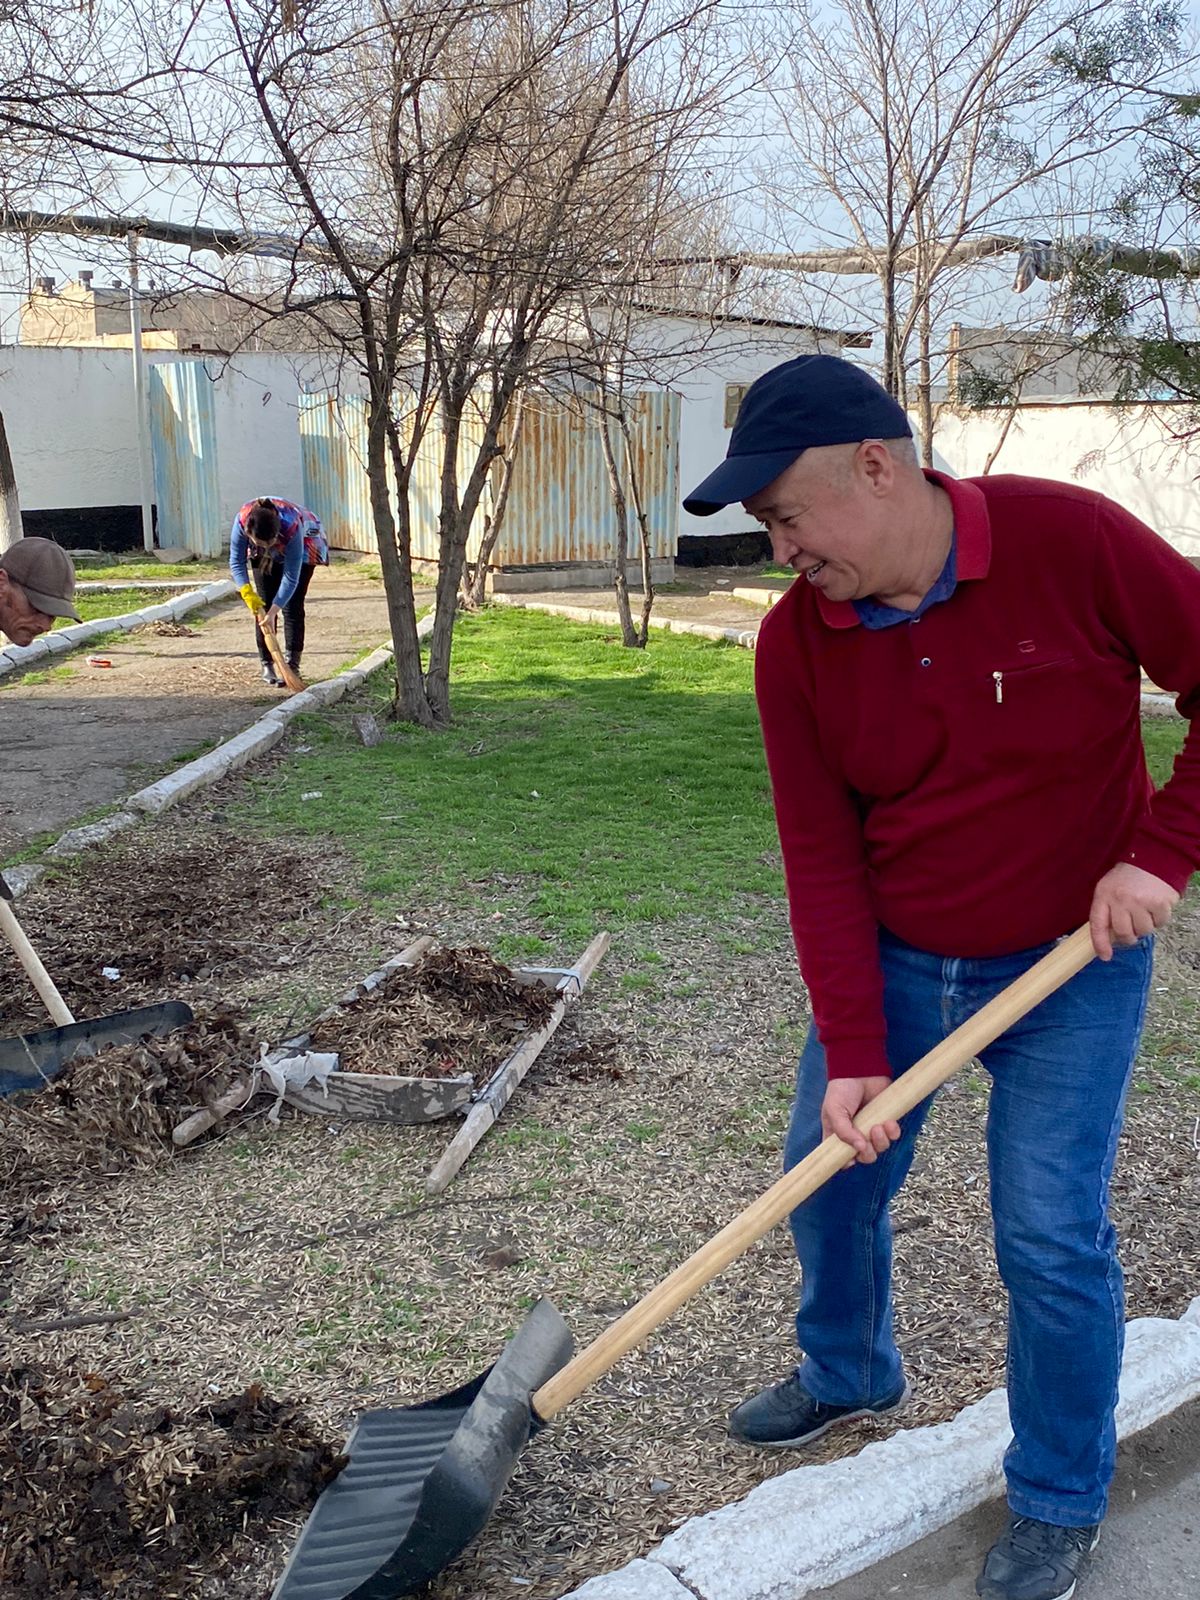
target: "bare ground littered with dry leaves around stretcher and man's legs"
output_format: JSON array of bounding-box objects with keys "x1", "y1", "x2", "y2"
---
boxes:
[{"x1": 0, "y1": 777, "x2": 1200, "y2": 1600}]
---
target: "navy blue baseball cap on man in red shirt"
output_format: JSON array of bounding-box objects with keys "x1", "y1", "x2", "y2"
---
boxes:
[{"x1": 683, "y1": 355, "x2": 912, "y2": 517}]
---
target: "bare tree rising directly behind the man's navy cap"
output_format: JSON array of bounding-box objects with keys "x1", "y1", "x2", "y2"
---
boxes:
[{"x1": 755, "y1": 0, "x2": 1174, "y2": 462}]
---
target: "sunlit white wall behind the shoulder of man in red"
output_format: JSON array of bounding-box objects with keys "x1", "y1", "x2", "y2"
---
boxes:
[{"x1": 933, "y1": 400, "x2": 1200, "y2": 558}]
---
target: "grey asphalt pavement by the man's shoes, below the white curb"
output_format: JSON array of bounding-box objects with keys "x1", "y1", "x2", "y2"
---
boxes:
[{"x1": 821, "y1": 1402, "x2": 1200, "y2": 1600}]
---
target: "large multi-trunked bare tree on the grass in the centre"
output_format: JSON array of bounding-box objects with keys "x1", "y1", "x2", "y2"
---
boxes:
[{"x1": 188, "y1": 0, "x2": 739, "y2": 726}]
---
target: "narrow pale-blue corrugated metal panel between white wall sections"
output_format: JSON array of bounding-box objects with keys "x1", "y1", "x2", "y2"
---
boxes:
[{"x1": 146, "y1": 362, "x2": 224, "y2": 555}]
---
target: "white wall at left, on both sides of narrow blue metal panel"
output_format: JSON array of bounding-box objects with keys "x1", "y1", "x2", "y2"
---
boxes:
[{"x1": 0, "y1": 346, "x2": 342, "y2": 528}]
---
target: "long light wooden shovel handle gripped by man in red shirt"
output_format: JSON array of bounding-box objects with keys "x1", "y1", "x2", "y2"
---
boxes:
[{"x1": 533, "y1": 926, "x2": 1094, "y2": 1422}]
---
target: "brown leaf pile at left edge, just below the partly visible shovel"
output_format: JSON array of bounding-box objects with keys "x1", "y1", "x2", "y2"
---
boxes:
[{"x1": 0, "y1": 1011, "x2": 256, "y2": 1202}]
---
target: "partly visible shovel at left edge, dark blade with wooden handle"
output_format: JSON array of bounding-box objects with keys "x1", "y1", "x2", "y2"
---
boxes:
[{"x1": 0, "y1": 875, "x2": 192, "y2": 1096}]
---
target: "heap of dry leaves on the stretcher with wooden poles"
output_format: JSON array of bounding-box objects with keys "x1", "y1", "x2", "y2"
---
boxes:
[{"x1": 310, "y1": 946, "x2": 555, "y2": 1085}]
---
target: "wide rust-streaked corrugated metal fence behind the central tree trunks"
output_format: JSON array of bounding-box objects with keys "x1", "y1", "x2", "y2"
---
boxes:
[{"x1": 301, "y1": 392, "x2": 680, "y2": 566}]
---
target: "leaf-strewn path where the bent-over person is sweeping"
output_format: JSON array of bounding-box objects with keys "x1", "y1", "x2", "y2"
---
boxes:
[{"x1": 0, "y1": 562, "x2": 404, "y2": 859}]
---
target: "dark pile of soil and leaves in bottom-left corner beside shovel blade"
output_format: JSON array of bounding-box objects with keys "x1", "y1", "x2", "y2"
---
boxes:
[{"x1": 0, "y1": 1366, "x2": 342, "y2": 1600}]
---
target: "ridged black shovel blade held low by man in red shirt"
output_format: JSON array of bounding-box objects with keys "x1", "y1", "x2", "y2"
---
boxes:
[{"x1": 272, "y1": 1299, "x2": 574, "y2": 1600}]
